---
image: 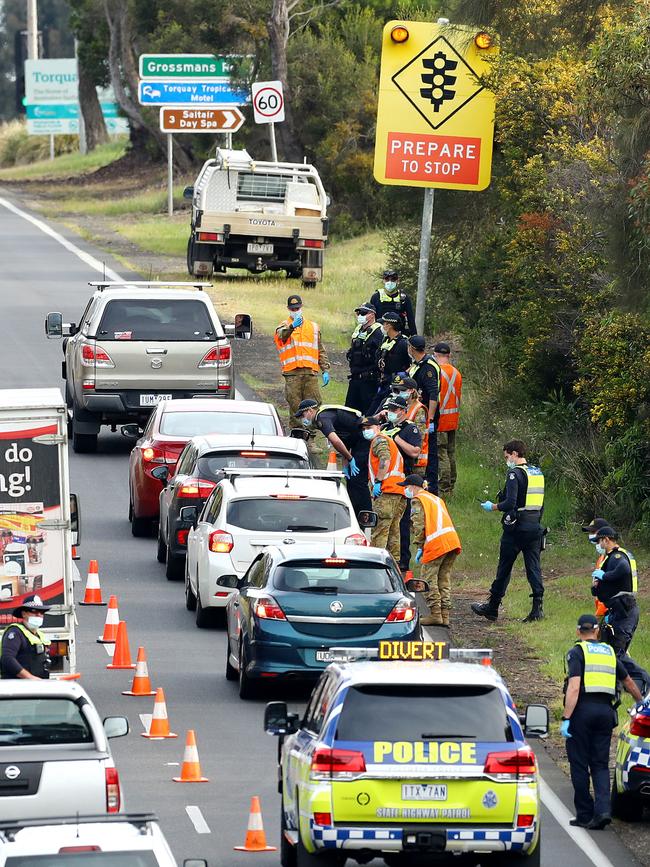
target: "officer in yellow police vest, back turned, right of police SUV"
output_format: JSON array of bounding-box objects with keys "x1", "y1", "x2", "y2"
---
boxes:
[{"x1": 560, "y1": 614, "x2": 641, "y2": 831}]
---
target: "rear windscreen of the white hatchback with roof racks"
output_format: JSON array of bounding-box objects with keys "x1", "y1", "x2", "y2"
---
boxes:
[{"x1": 226, "y1": 497, "x2": 350, "y2": 533}]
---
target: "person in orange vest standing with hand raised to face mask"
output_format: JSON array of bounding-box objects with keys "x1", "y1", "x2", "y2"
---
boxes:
[{"x1": 275, "y1": 295, "x2": 330, "y2": 426}]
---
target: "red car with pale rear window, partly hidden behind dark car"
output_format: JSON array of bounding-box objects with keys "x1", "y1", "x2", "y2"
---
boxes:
[{"x1": 121, "y1": 398, "x2": 284, "y2": 536}]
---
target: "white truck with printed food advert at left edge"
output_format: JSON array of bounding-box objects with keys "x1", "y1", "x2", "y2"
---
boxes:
[{"x1": 0, "y1": 388, "x2": 79, "y2": 677}]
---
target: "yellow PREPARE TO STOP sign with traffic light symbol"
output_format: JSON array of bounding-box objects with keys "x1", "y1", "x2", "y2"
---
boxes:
[{"x1": 374, "y1": 21, "x2": 495, "y2": 190}]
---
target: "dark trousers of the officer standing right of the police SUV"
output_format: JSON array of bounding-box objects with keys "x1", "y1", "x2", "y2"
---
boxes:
[{"x1": 566, "y1": 699, "x2": 616, "y2": 822}]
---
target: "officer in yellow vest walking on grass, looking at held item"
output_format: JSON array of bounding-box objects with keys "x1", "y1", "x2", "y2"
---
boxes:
[{"x1": 472, "y1": 440, "x2": 544, "y2": 623}]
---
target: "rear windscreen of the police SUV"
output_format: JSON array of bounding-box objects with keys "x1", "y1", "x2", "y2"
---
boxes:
[{"x1": 336, "y1": 688, "x2": 513, "y2": 742}]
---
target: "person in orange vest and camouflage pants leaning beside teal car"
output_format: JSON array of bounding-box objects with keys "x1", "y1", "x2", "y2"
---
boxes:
[{"x1": 400, "y1": 473, "x2": 461, "y2": 626}]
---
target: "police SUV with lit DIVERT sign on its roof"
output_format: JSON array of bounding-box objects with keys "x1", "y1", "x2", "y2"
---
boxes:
[{"x1": 265, "y1": 642, "x2": 548, "y2": 867}]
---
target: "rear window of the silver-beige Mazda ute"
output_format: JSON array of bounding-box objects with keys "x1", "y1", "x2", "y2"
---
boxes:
[{"x1": 96, "y1": 298, "x2": 215, "y2": 341}]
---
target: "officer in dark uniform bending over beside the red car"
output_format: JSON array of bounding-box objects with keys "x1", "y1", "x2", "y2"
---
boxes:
[{"x1": 296, "y1": 398, "x2": 372, "y2": 515}]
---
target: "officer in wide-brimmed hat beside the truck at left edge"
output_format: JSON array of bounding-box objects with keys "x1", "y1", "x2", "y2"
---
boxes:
[{"x1": 0, "y1": 595, "x2": 50, "y2": 680}]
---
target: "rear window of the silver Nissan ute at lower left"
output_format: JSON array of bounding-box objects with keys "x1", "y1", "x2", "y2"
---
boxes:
[{"x1": 0, "y1": 698, "x2": 93, "y2": 744}]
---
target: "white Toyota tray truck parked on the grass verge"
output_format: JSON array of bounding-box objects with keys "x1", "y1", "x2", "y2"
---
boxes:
[{"x1": 184, "y1": 148, "x2": 329, "y2": 287}]
